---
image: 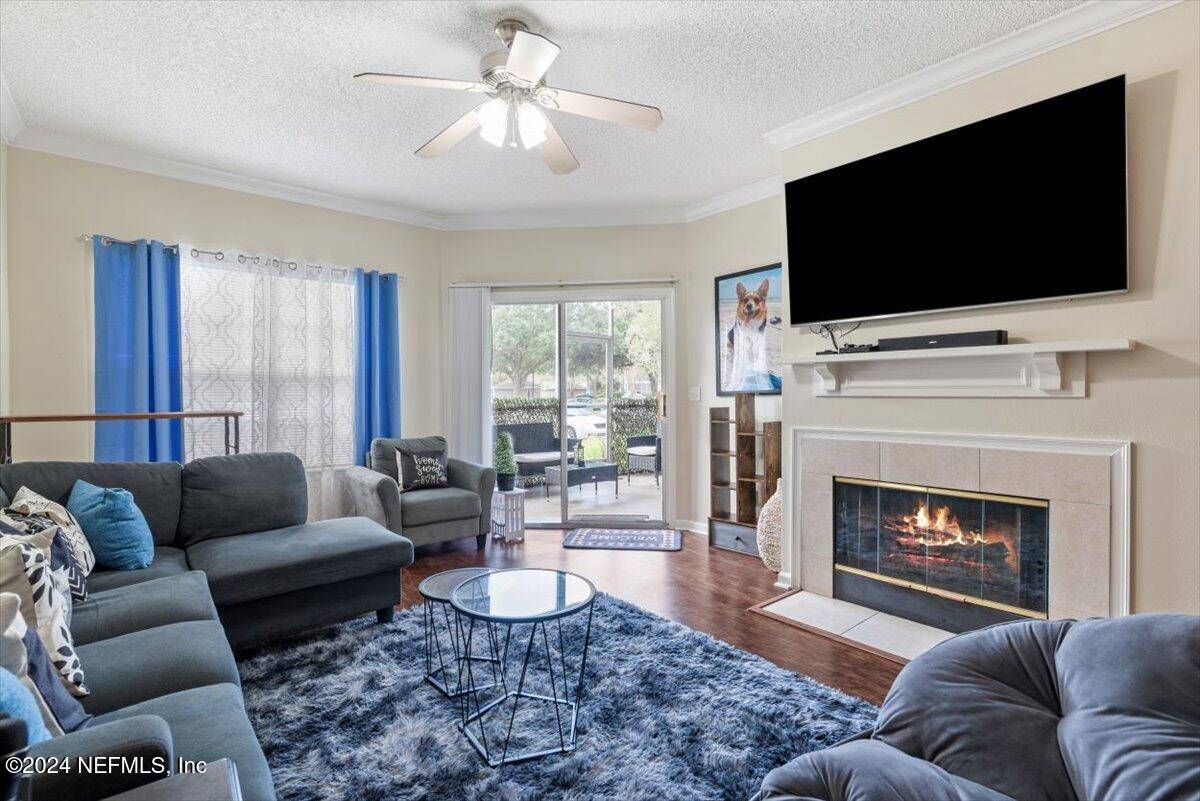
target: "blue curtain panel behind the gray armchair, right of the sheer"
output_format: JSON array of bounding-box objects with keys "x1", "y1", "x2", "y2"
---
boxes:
[{"x1": 354, "y1": 269, "x2": 400, "y2": 464}]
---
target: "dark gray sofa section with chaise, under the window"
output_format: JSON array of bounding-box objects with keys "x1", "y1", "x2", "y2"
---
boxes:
[{"x1": 0, "y1": 453, "x2": 413, "y2": 649}]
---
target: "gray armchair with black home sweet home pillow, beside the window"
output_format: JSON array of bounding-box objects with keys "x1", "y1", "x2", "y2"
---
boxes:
[{"x1": 346, "y1": 436, "x2": 496, "y2": 548}]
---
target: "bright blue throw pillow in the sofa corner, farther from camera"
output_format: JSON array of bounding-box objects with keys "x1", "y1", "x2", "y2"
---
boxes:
[{"x1": 67, "y1": 481, "x2": 154, "y2": 570}]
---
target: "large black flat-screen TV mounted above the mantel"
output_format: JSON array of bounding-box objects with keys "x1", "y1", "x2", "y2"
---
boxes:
[{"x1": 785, "y1": 76, "x2": 1129, "y2": 325}]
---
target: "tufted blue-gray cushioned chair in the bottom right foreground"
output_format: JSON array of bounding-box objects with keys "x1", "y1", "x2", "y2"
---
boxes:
[{"x1": 754, "y1": 614, "x2": 1200, "y2": 801}]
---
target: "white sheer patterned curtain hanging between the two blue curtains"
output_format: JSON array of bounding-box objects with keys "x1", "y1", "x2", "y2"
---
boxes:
[{"x1": 179, "y1": 245, "x2": 354, "y2": 519}]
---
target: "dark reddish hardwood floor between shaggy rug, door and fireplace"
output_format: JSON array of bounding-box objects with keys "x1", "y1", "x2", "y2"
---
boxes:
[{"x1": 403, "y1": 530, "x2": 900, "y2": 704}]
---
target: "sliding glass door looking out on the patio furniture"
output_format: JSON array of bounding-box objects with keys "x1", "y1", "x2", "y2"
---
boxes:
[{"x1": 492, "y1": 288, "x2": 672, "y2": 528}]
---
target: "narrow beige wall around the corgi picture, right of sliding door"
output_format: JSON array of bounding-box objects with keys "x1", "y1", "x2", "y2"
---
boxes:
[{"x1": 677, "y1": 195, "x2": 787, "y2": 531}]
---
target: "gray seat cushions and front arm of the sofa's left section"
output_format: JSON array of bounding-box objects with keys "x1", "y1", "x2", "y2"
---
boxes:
[{"x1": 22, "y1": 571, "x2": 275, "y2": 801}]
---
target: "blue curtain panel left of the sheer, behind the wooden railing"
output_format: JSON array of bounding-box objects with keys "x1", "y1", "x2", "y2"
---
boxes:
[{"x1": 92, "y1": 236, "x2": 184, "y2": 462}]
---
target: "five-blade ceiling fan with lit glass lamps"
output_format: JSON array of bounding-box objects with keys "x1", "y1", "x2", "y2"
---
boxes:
[{"x1": 354, "y1": 19, "x2": 662, "y2": 175}]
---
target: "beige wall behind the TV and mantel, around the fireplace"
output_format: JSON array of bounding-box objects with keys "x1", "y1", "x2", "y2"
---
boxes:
[{"x1": 784, "y1": 2, "x2": 1200, "y2": 614}]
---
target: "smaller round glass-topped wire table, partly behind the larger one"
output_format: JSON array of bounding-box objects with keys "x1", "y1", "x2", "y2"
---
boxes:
[{"x1": 416, "y1": 567, "x2": 499, "y2": 698}]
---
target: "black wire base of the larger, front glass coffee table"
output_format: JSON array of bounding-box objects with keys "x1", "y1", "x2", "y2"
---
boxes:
[{"x1": 457, "y1": 603, "x2": 593, "y2": 767}]
